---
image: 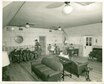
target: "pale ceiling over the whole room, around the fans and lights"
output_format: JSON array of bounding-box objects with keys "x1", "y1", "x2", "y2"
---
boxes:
[{"x1": 3, "y1": 1, "x2": 102, "y2": 28}]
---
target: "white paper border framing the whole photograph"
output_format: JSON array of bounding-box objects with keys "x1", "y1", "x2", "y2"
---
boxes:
[{"x1": 0, "y1": 0, "x2": 104, "y2": 84}]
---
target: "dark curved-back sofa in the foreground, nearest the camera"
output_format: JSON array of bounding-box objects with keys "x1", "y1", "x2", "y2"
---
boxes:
[{"x1": 31, "y1": 56, "x2": 63, "y2": 81}]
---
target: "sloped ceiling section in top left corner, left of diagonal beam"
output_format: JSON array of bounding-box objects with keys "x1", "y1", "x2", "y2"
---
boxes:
[{"x1": 3, "y1": 2, "x2": 23, "y2": 27}]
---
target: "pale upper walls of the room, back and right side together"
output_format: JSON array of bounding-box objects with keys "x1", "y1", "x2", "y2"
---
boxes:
[{"x1": 3, "y1": 23, "x2": 102, "y2": 55}]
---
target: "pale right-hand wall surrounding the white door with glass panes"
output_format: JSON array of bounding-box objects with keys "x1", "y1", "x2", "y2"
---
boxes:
[{"x1": 65, "y1": 23, "x2": 102, "y2": 56}]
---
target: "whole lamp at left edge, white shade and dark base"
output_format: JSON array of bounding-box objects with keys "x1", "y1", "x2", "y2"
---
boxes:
[{"x1": 2, "y1": 51, "x2": 10, "y2": 81}]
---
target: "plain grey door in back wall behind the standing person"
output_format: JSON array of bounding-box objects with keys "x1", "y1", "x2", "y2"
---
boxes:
[{"x1": 39, "y1": 36, "x2": 46, "y2": 55}]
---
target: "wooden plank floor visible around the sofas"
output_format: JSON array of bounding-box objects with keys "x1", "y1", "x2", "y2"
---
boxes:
[{"x1": 8, "y1": 56, "x2": 102, "y2": 82}]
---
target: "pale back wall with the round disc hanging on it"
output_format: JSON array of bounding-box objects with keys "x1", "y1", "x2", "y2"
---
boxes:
[{"x1": 3, "y1": 27, "x2": 63, "y2": 54}]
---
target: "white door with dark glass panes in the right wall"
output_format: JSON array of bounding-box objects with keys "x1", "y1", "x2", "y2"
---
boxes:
[{"x1": 83, "y1": 36, "x2": 93, "y2": 57}]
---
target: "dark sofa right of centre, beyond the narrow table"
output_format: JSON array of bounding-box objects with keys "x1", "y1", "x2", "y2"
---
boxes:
[{"x1": 59, "y1": 56, "x2": 90, "y2": 81}]
